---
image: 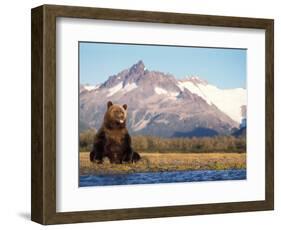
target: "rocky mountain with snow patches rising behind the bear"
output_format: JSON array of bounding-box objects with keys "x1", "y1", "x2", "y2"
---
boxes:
[{"x1": 80, "y1": 61, "x2": 246, "y2": 137}]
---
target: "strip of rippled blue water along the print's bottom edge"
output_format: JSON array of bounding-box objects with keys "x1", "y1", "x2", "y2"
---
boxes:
[{"x1": 79, "y1": 169, "x2": 246, "y2": 187}]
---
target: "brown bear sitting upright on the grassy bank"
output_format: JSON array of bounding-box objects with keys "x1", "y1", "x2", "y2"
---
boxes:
[{"x1": 90, "y1": 101, "x2": 141, "y2": 164}]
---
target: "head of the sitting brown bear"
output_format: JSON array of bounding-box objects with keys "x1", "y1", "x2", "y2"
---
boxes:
[{"x1": 104, "y1": 101, "x2": 127, "y2": 129}]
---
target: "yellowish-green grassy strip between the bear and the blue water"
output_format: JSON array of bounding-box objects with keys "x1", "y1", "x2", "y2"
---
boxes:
[{"x1": 80, "y1": 152, "x2": 246, "y2": 175}]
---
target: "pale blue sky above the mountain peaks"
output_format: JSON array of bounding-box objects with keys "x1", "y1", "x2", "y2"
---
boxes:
[{"x1": 79, "y1": 42, "x2": 247, "y2": 88}]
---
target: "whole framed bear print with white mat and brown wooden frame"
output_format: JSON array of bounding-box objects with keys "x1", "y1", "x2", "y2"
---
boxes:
[{"x1": 31, "y1": 5, "x2": 274, "y2": 224}]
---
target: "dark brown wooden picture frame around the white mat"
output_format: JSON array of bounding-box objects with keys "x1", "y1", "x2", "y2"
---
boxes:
[{"x1": 31, "y1": 5, "x2": 274, "y2": 224}]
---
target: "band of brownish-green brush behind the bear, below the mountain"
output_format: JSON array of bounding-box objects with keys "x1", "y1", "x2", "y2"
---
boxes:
[{"x1": 79, "y1": 129, "x2": 246, "y2": 153}]
